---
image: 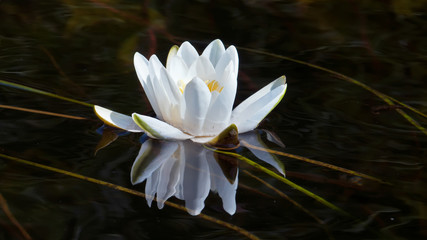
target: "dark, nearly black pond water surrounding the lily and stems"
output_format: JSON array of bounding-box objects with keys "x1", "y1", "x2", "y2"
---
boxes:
[{"x1": 0, "y1": 0, "x2": 427, "y2": 239}]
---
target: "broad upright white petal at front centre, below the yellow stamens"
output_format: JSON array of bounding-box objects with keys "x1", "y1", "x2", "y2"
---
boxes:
[{"x1": 183, "y1": 78, "x2": 211, "y2": 136}]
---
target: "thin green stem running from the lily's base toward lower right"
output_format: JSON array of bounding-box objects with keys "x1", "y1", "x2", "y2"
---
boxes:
[{"x1": 205, "y1": 146, "x2": 349, "y2": 216}]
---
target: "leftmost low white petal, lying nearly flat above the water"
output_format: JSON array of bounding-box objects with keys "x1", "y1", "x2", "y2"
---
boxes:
[{"x1": 93, "y1": 105, "x2": 143, "y2": 132}]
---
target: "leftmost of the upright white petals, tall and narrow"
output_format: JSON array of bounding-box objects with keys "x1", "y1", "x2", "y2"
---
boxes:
[{"x1": 133, "y1": 52, "x2": 163, "y2": 119}]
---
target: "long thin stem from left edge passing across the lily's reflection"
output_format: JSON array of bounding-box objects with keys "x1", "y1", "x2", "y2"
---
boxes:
[{"x1": 0, "y1": 153, "x2": 259, "y2": 240}]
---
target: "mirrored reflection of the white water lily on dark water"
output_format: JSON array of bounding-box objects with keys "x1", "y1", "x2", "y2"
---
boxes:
[{"x1": 131, "y1": 132, "x2": 284, "y2": 215}]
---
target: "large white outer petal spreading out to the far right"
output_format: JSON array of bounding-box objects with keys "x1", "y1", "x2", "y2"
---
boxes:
[{"x1": 231, "y1": 76, "x2": 287, "y2": 133}]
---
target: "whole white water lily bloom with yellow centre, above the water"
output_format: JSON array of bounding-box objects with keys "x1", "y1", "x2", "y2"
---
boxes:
[{"x1": 95, "y1": 40, "x2": 287, "y2": 142}]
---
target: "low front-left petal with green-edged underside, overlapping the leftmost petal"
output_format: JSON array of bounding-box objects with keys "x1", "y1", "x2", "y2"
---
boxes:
[{"x1": 132, "y1": 113, "x2": 193, "y2": 140}]
